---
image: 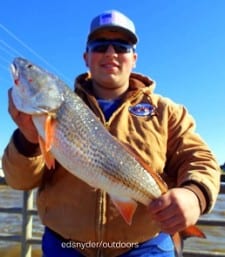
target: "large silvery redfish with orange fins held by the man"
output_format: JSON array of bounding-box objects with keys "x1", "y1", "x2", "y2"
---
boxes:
[{"x1": 11, "y1": 58, "x2": 204, "y2": 240}]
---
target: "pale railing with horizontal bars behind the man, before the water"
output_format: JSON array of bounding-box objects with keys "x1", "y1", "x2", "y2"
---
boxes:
[{"x1": 0, "y1": 175, "x2": 225, "y2": 257}]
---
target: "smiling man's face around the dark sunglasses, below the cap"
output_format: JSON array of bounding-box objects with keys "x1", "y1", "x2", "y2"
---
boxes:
[{"x1": 84, "y1": 31, "x2": 137, "y2": 89}]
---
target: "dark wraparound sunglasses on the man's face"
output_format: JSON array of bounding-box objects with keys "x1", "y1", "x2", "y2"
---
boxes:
[{"x1": 87, "y1": 40, "x2": 134, "y2": 54}]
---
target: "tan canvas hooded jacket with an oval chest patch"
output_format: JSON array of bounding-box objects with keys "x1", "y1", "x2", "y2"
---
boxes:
[{"x1": 2, "y1": 73, "x2": 220, "y2": 257}]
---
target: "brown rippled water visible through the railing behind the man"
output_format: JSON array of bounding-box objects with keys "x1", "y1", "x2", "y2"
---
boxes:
[{"x1": 0, "y1": 183, "x2": 225, "y2": 257}]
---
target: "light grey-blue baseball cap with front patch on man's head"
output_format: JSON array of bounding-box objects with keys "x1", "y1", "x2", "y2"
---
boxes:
[{"x1": 87, "y1": 10, "x2": 138, "y2": 45}]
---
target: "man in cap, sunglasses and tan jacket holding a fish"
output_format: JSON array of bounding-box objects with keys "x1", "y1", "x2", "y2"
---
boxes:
[{"x1": 3, "y1": 10, "x2": 220, "y2": 257}]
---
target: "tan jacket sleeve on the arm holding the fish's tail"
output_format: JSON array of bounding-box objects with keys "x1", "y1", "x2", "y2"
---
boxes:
[{"x1": 166, "y1": 99, "x2": 221, "y2": 213}]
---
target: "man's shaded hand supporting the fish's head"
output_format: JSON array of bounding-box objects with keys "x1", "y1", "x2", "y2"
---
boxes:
[{"x1": 8, "y1": 89, "x2": 38, "y2": 144}]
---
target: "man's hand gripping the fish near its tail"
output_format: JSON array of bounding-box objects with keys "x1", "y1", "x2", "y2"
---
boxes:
[{"x1": 149, "y1": 188, "x2": 200, "y2": 235}]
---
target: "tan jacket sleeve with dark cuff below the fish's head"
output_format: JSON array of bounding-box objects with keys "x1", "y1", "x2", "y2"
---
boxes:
[{"x1": 2, "y1": 130, "x2": 45, "y2": 190}]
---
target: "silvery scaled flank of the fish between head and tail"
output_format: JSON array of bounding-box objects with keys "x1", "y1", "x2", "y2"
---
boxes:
[{"x1": 43, "y1": 84, "x2": 161, "y2": 201}]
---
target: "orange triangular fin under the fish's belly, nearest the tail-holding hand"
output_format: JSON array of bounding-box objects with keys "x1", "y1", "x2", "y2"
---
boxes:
[{"x1": 111, "y1": 196, "x2": 137, "y2": 225}]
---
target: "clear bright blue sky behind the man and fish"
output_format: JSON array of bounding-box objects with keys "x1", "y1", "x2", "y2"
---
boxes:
[{"x1": 0, "y1": 0, "x2": 225, "y2": 164}]
